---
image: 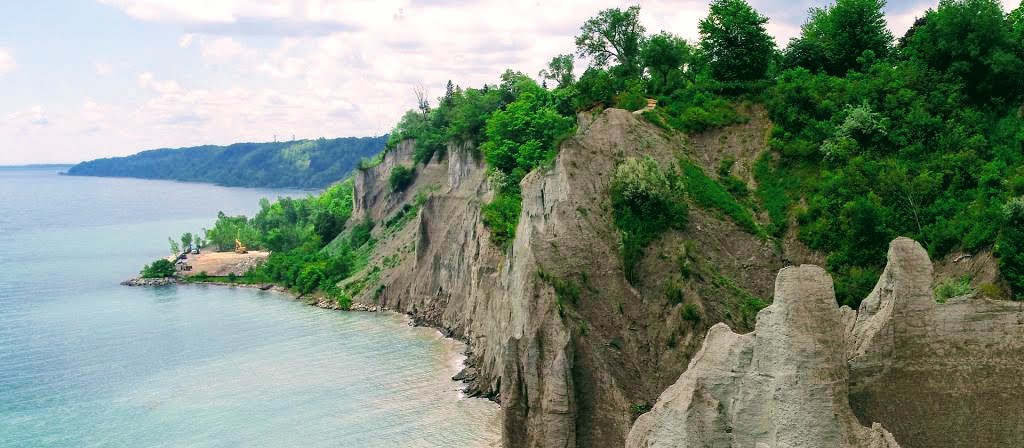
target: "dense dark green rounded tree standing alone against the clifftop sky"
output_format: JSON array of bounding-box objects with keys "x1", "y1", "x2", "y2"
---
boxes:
[{"x1": 698, "y1": 0, "x2": 775, "y2": 81}]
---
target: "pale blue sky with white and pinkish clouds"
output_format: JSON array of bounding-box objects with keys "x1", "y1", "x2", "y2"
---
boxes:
[{"x1": 0, "y1": 0, "x2": 1019, "y2": 165}]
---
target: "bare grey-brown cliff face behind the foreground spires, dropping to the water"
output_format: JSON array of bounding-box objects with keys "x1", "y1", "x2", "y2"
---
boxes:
[{"x1": 354, "y1": 109, "x2": 811, "y2": 447}]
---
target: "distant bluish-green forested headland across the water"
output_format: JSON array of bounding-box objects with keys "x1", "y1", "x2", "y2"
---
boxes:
[{"x1": 68, "y1": 136, "x2": 387, "y2": 188}]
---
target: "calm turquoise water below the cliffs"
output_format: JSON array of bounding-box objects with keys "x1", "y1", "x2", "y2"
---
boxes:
[{"x1": 0, "y1": 169, "x2": 499, "y2": 447}]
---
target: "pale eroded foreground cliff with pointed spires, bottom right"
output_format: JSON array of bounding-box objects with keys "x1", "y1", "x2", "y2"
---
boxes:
[{"x1": 628, "y1": 238, "x2": 1024, "y2": 448}]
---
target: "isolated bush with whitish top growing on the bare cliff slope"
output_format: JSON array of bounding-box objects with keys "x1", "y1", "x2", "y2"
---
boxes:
[{"x1": 610, "y1": 156, "x2": 687, "y2": 283}]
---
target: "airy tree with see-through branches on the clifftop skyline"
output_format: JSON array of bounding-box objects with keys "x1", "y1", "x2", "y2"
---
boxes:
[{"x1": 575, "y1": 6, "x2": 645, "y2": 76}]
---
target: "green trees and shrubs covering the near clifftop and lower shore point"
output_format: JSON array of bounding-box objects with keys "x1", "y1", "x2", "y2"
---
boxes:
[{"x1": 161, "y1": 0, "x2": 1024, "y2": 308}]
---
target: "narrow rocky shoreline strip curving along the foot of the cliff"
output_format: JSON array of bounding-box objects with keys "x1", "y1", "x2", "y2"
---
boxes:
[{"x1": 121, "y1": 277, "x2": 491, "y2": 406}]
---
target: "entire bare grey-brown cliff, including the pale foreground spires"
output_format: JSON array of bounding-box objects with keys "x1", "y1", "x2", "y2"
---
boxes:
[{"x1": 351, "y1": 108, "x2": 1024, "y2": 448}]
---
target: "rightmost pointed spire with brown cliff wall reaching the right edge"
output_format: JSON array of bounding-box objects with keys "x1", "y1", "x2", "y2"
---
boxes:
[{"x1": 847, "y1": 238, "x2": 1024, "y2": 448}]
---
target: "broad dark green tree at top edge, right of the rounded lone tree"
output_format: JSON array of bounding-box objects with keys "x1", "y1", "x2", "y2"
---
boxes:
[{"x1": 784, "y1": 0, "x2": 893, "y2": 76}]
